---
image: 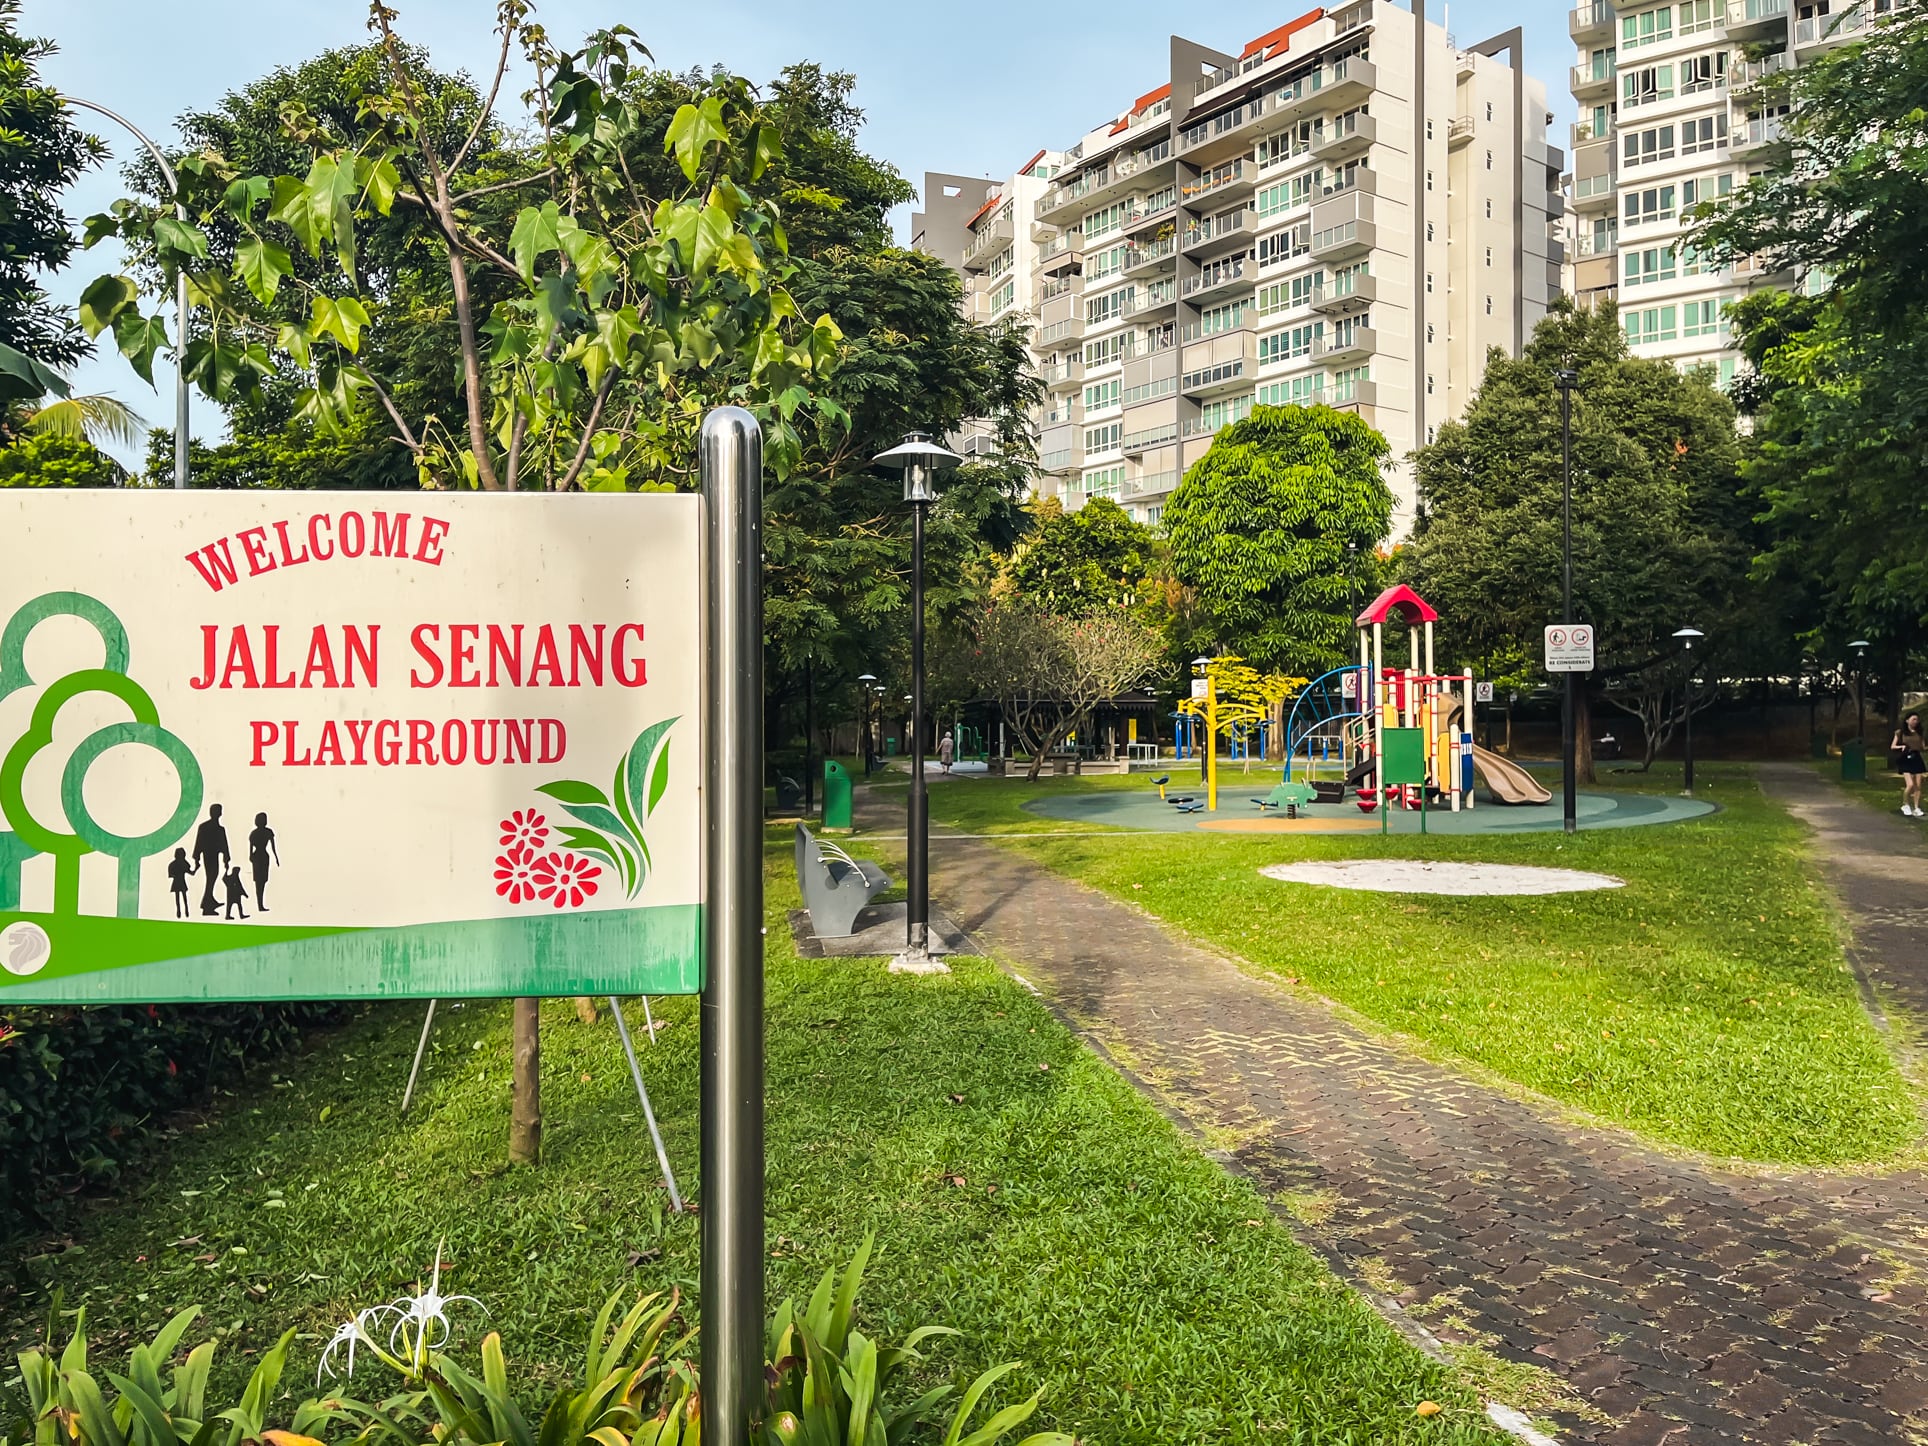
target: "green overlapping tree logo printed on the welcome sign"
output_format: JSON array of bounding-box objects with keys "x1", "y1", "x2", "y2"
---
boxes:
[{"x1": 0, "y1": 592, "x2": 202, "y2": 920}]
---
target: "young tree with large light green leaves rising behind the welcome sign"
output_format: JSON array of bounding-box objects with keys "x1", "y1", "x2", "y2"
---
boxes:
[{"x1": 81, "y1": 0, "x2": 841, "y2": 490}]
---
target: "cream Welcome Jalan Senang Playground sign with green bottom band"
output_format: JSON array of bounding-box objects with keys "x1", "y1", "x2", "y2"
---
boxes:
[{"x1": 0, "y1": 492, "x2": 702, "y2": 1004}]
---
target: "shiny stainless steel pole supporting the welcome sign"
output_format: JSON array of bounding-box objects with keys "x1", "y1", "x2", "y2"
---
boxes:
[{"x1": 698, "y1": 407, "x2": 765, "y2": 1446}]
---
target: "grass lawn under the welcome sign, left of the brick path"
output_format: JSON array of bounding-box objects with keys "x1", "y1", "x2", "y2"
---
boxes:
[{"x1": 0, "y1": 843, "x2": 1500, "y2": 1446}]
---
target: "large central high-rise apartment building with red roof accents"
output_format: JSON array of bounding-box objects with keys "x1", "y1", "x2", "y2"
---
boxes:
[{"x1": 912, "y1": 0, "x2": 1564, "y2": 530}]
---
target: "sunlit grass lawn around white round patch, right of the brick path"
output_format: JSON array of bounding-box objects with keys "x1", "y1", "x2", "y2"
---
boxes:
[{"x1": 910, "y1": 763, "x2": 1920, "y2": 1165}]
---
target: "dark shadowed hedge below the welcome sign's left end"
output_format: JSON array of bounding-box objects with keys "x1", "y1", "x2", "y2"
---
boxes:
[{"x1": 0, "y1": 1004, "x2": 337, "y2": 1244}]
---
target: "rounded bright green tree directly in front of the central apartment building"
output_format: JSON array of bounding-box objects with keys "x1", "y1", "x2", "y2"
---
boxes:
[{"x1": 1165, "y1": 407, "x2": 1392, "y2": 675}]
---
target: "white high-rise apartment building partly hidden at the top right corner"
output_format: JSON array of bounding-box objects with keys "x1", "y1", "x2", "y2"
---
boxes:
[{"x1": 1567, "y1": 0, "x2": 1895, "y2": 386}]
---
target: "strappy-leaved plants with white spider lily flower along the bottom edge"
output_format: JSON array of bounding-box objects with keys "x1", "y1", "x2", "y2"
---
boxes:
[{"x1": 0, "y1": 1240, "x2": 1074, "y2": 1446}]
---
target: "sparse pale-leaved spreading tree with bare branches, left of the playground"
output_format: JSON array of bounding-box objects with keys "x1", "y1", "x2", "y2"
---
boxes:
[{"x1": 933, "y1": 594, "x2": 1163, "y2": 781}]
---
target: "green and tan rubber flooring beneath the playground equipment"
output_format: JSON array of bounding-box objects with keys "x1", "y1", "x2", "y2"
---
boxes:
[{"x1": 1024, "y1": 775, "x2": 1714, "y2": 833}]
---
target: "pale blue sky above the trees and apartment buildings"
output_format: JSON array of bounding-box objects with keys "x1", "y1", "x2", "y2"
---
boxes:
[{"x1": 21, "y1": 0, "x2": 1573, "y2": 461}]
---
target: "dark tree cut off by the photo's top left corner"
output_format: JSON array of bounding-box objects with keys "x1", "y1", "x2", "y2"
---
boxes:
[{"x1": 0, "y1": 0, "x2": 106, "y2": 379}]
